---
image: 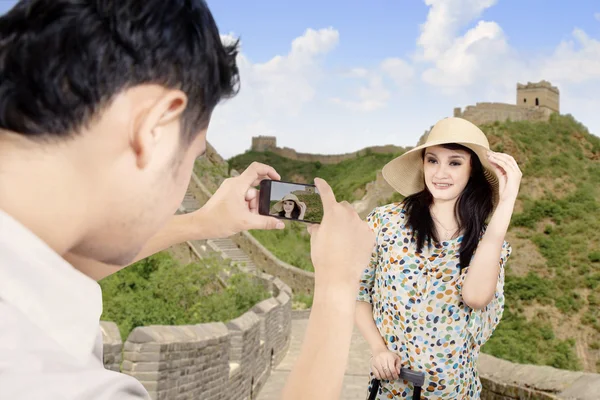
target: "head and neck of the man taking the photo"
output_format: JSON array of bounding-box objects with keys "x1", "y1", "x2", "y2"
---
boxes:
[{"x1": 0, "y1": 0, "x2": 238, "y2": 265}]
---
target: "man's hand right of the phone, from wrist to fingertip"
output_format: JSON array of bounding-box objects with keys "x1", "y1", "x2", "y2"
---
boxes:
[{"x1": 308, "y1": 178, "x2": 375, "y2": 289}]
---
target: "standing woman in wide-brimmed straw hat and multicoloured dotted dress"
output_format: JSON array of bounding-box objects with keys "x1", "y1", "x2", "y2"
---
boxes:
[{"x1": 356, "y1": 118, "x2": 522, "y2": 399}]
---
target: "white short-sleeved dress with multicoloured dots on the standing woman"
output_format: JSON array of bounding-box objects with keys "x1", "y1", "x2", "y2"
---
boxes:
[{"x1": 357, "y1": 203, "x2": 511, "y2": 400}]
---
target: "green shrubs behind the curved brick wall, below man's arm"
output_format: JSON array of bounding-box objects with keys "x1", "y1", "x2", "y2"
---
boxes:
[{"x1": 100, "y1": 252, "x2": 270, "y2": 340}]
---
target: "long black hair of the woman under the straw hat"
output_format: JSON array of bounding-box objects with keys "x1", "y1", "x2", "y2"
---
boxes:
[{"x1": 403, "y1": 143, "x2": 493, "y2": 270}]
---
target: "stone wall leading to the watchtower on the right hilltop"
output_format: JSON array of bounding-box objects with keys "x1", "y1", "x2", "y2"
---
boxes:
[{"x1": 454, "y1": 103, "x2": 552, "y2": 125}]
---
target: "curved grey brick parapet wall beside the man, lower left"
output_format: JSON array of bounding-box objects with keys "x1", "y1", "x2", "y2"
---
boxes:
[{"x1": 102, "y1": 274, "x2": 291, "y2": 400}]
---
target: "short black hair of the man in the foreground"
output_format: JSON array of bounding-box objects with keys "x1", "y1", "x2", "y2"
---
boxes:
[{"x1": 0, "y1": 0, "x2": 239, "y2": 144}]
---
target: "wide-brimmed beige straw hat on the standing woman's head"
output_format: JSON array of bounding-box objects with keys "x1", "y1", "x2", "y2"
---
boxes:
[{"x1": 382, "y1": 117, "x2": 499, "y2": 208}]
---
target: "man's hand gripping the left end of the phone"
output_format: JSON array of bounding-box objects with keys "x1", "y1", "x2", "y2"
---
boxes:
[{"x1": 194, "y1": 162, "x2": 285, "y2": 239}]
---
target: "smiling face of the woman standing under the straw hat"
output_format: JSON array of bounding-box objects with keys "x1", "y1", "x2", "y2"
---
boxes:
[{"x1": 423, "y1": 146, "x2": 471, "y2": 201}]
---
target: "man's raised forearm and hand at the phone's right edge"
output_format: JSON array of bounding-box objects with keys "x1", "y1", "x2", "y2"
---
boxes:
[{"x1": 281, "y1": 179, "x2": 375, "y2": 400}]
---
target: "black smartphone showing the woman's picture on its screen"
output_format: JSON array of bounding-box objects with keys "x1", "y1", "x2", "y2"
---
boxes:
[{"x1": 258, "y1": 179, "x2": 323, "y2": 224}]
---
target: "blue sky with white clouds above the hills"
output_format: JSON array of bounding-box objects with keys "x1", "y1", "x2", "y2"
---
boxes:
[{"x1": 0, "y1": 0, "x2": 600, "y2": 157}]
